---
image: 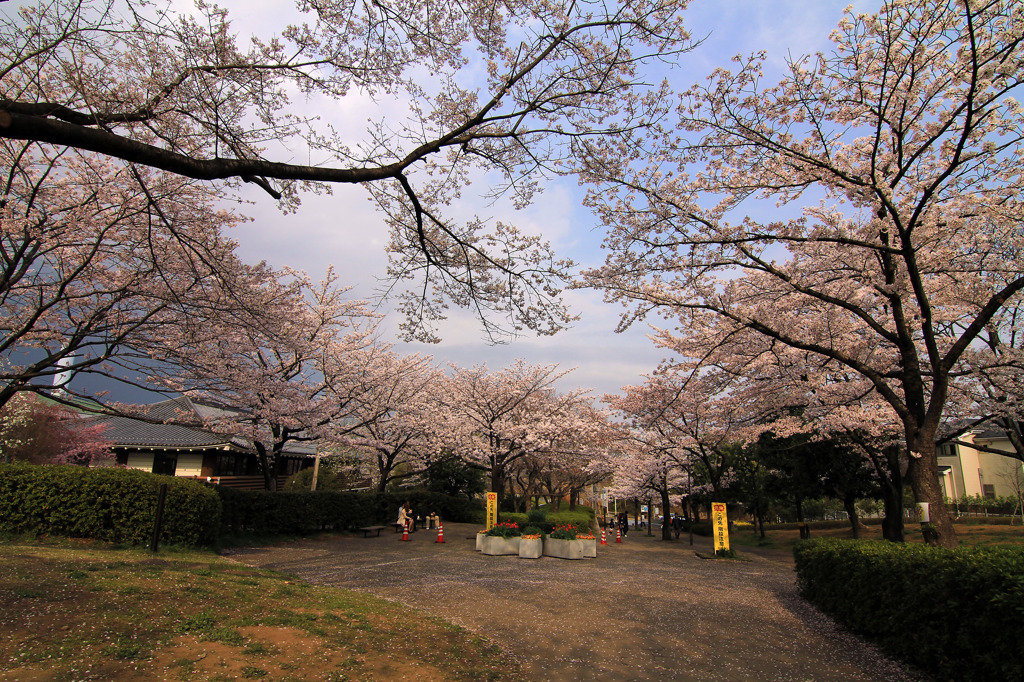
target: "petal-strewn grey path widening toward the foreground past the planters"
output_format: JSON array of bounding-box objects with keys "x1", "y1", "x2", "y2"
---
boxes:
[{"x1": 231, "y1": 523, "x2": 918, "y2": 681}]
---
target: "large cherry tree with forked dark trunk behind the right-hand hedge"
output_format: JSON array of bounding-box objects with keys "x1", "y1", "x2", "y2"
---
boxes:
[{"x1": 588, "y1": 0, "x2": 1024, "y2": 547}]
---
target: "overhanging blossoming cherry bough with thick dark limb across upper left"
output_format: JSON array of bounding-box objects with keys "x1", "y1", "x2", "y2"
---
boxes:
[{"x1": 0, "y1": 0, "x2": 689, "y2": 338}]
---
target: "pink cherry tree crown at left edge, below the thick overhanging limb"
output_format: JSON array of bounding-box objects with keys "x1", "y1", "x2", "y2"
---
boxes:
[{"x1": 0, "y1": 140, "x2": 245, "y2": 406}]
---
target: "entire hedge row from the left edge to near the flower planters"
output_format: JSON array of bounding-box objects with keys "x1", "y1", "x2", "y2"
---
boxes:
[{"x1": 0, "y1": 464, "x2": 483, "y2": 547}]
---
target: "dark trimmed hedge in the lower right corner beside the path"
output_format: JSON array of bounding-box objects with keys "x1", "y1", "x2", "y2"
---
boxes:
[{"x1": 794, "y1": 539, "x2": 1024, "y2": 681}]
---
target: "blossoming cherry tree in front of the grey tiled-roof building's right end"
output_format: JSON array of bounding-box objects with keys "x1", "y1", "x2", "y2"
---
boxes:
[{"x1": 129, "y1": 265, "x2": 380, "y2": 489}]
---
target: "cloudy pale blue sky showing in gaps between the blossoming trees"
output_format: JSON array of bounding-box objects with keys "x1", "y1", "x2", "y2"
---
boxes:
[{"x1": 199, "y1": 0, "x2": 880, "y2": 398}]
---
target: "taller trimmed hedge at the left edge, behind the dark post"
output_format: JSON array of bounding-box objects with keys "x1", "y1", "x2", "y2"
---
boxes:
[{"x1": 0, "y1": 464, "x2": 221, "y2": 547}]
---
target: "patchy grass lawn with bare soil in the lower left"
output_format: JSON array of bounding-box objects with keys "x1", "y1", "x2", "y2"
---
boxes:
[{"x1": 0, "y1": 541, "x2": 521, "y2": 681}]
